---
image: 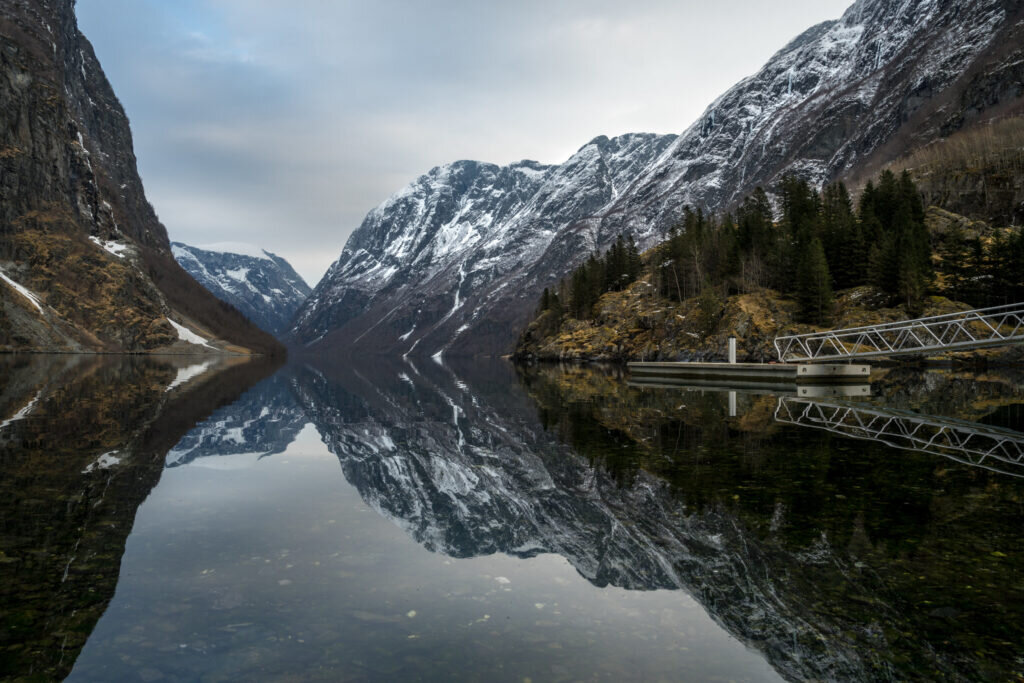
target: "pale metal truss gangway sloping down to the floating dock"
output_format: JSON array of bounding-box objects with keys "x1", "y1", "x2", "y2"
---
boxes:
[{"x1": 775, "y1": 303, "x2": 1024, "y2": 362}]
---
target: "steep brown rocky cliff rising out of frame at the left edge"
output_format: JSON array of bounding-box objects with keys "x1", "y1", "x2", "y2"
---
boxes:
[{"x1": 0, "y1": 0, "x2": 280, "y2": 352}]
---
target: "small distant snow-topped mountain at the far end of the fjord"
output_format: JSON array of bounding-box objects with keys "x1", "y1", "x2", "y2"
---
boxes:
[{"x1": 171, "y1": 242, "x2": 311, "y2": 335}]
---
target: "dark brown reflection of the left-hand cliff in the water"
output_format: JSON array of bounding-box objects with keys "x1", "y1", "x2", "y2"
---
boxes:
[{"x1": 0, "y1": 355, "x2": 274, "y2": 680}]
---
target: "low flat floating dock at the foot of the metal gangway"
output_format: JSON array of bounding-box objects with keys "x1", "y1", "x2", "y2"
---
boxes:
[{"x1": 629, "y1": 362, "x2": 871, "y2": 388}]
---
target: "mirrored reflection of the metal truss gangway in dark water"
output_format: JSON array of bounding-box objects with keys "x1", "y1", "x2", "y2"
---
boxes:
[{"x1": 775, "y1": 396, "x2": 1024, "y2": 478}]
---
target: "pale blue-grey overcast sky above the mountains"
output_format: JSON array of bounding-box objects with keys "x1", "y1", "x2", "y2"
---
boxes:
[{"x1": 78, "y1": 0, "x2": 852, "y2": 285}]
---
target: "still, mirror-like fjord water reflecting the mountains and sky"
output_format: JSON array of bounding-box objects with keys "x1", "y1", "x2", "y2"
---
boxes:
[{"x1": 0, "y1": 358, "x2": 1024, "y2": 681}]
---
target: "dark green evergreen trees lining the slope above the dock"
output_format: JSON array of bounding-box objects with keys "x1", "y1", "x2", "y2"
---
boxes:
[{"x1": 538, "y1": 170, "x2": 1024, "y2": 325}]
